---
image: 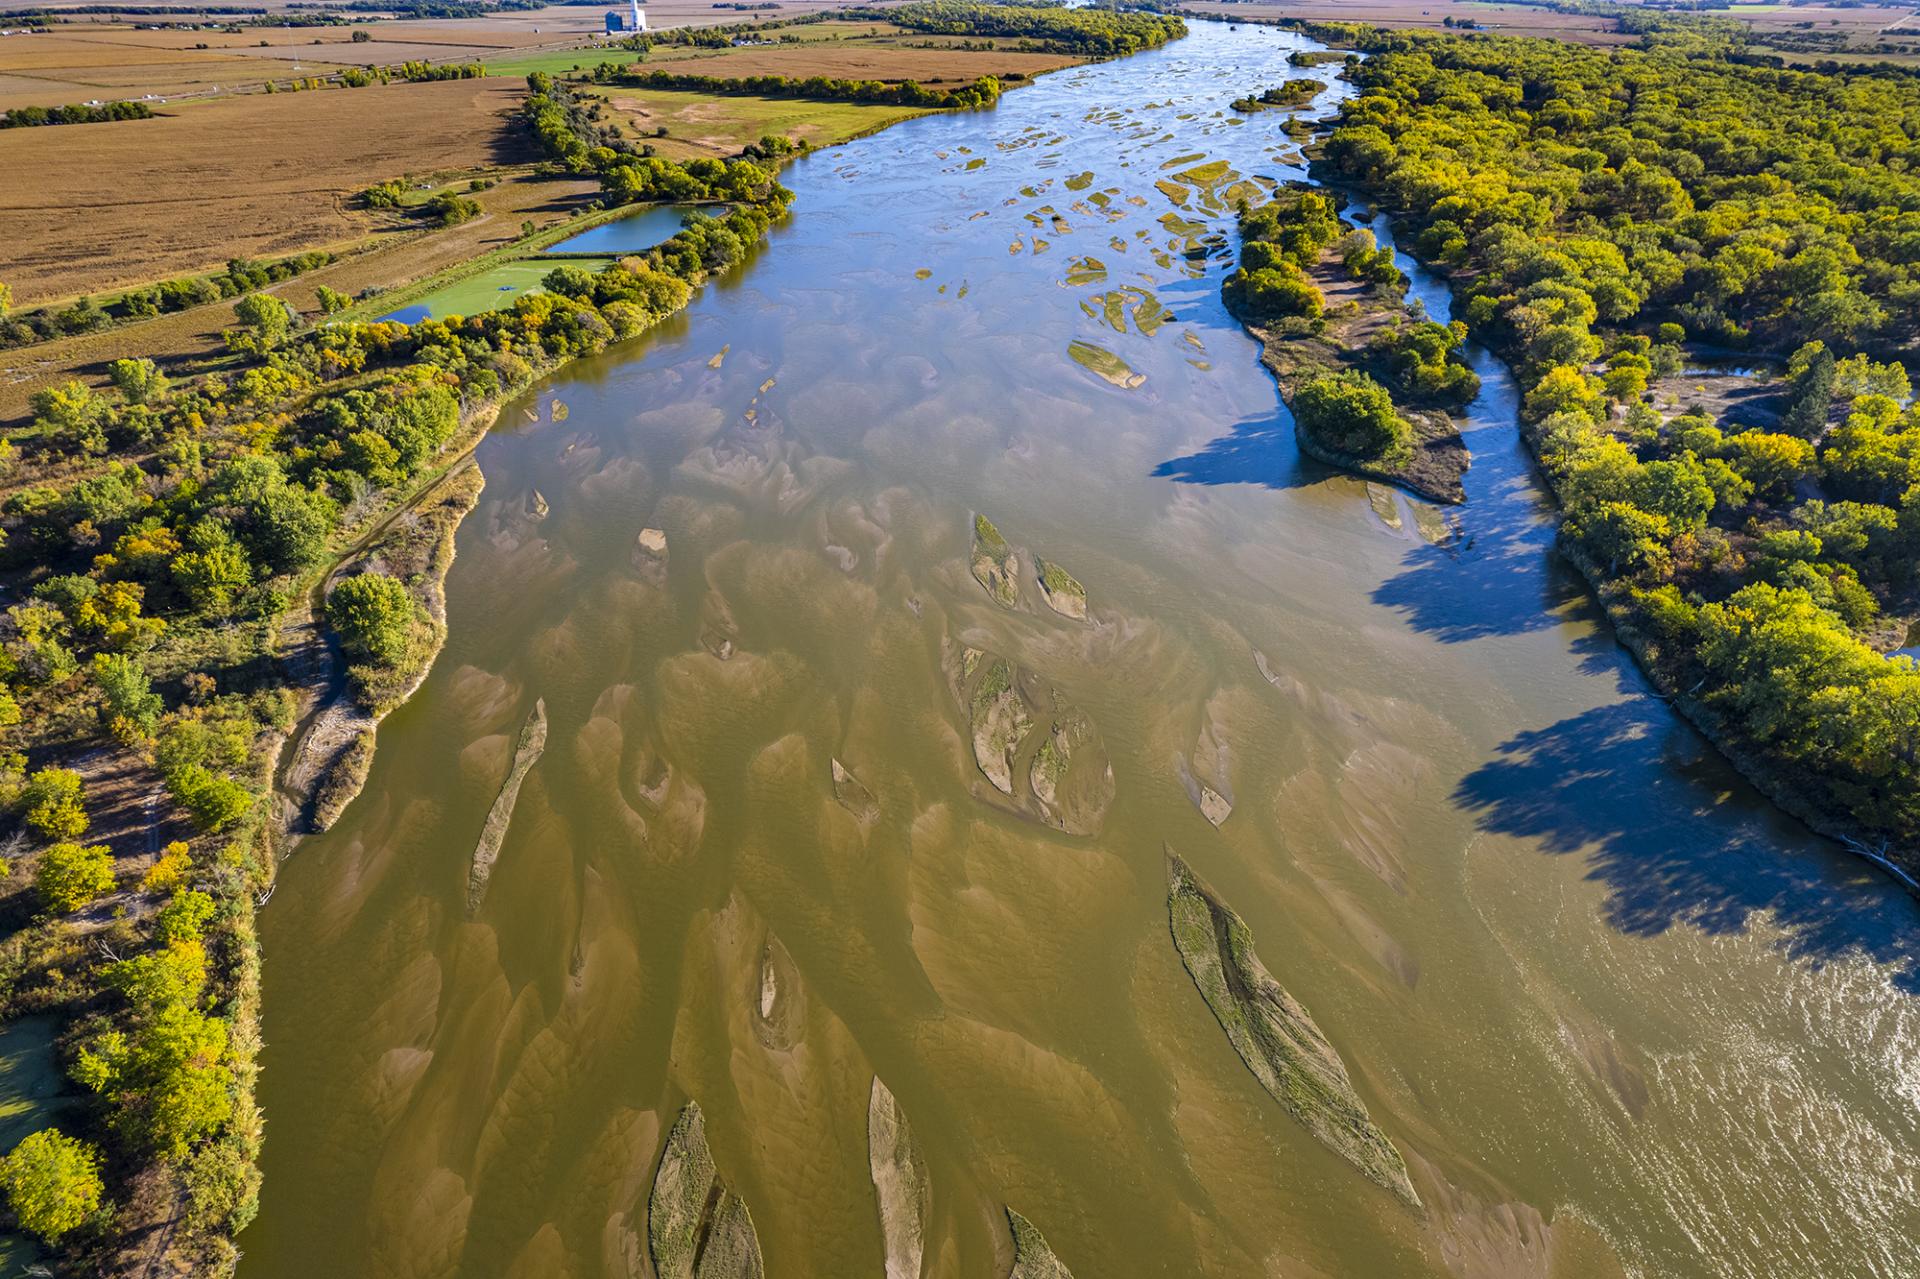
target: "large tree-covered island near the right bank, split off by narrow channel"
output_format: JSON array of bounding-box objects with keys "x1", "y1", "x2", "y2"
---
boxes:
[{"x1": 1221, "y1": 186, "x2": 1480, "y2": 503}]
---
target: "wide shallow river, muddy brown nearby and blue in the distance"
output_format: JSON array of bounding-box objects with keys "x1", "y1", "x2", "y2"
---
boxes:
[{"x1": 242, "y1": 23, "x2": 1920, "y2": 1279}]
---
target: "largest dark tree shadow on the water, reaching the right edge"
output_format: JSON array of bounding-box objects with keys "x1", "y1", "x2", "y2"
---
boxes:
[{"x1": 1453, "y1": 697, "x2": 1920, "y2": 995}]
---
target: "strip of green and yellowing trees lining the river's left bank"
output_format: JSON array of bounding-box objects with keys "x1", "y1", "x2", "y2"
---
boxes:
[{"x1": 0, "y1": 75, "x2": 793, "y2": 1273}]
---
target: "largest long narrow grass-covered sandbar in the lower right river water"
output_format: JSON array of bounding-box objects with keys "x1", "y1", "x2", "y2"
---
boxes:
[{"x1": 1167, "y1": 851, "x2": 1421, "y2": 1208}]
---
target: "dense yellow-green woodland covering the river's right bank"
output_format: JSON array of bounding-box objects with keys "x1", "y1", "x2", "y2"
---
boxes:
[{"x1": 1325, "y1": 19, "x2": 1920, "y2": 844}]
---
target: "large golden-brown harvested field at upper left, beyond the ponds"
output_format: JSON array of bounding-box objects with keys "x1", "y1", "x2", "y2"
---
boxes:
[{"x1": 0, "y1": 79, "x2": 534, "y2": 303}]
